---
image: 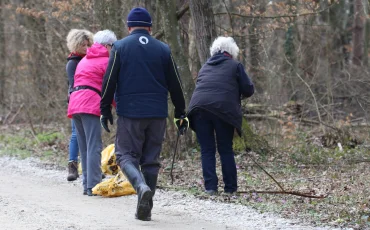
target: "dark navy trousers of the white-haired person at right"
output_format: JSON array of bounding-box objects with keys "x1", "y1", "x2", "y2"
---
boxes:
[{"x1": 192, "y1": 111, "x2": 237, "y2": 193}]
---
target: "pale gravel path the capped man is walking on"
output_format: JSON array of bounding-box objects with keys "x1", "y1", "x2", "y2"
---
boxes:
[{"x1": 0, "y1": 157, "x2": 336, "y2": 230}]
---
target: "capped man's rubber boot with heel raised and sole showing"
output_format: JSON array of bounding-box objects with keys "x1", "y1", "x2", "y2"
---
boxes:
[{"x1": 121, "y1": 162, "x2": 153, "y2": 221}]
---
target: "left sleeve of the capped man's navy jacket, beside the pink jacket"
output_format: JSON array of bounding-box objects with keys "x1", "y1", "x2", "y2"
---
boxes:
[{"x1": 100, "y1": 45, "x2": 121, "y2": 116}]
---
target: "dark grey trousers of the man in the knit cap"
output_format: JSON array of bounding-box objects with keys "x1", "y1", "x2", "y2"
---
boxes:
[{"x1": 115, "y1": 117, "x2": 166, "y2": 175}]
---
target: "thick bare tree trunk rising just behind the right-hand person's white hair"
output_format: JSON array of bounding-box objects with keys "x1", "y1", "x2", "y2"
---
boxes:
[{"x1": 190, "y1": 0, "x2": 217, "y2": 64}]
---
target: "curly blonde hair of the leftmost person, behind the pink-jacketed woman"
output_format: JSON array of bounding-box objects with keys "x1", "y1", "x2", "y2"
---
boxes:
[{"x1": 67, "y1": 29, "x2": 93, "y2": 52}]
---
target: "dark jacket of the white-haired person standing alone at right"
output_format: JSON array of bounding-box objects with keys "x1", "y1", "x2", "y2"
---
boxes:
[{"x1": 187, "y1": 52, "x2": 254, "y2": 135}]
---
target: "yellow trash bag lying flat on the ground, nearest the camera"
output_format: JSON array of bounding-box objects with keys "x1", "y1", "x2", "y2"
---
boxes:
[{"x1": 92, "y1": 170, "x2": 136, "y2": 197}]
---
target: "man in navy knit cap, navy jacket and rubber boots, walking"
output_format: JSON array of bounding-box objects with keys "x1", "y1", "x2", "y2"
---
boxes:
[{"x1": 100, "y1": 8, "x2": 188, "y2": 220}]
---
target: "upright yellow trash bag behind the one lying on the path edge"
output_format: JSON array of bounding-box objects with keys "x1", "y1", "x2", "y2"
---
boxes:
[{"x1": 78, "y1": 144, "x2": 120, "y2": 176}]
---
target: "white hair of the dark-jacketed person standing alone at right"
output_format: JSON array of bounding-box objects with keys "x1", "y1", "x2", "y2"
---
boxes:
[{"x1": 209, "y1": 37, "x2": 239, "y2": 59}]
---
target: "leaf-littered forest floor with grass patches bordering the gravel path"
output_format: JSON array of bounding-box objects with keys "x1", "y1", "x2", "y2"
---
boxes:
[{"x1": 0, "y1": 125, "x2": 370, "y2": 229}]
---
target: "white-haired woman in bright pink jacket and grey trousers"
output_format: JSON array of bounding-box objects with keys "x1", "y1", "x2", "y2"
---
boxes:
[{"x1": 68, "y1": 30, "x2": 117, "y2": 196}]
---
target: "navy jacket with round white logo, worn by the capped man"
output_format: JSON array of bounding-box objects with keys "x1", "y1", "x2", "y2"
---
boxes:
[{"x1": 100, "y1": 29, "x2": 185, "y2": 118}]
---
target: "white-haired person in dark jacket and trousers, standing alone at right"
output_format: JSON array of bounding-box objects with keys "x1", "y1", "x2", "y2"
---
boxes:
[{"x1": 188, "y1": 37, "x2": 254, "y2": 195}]
